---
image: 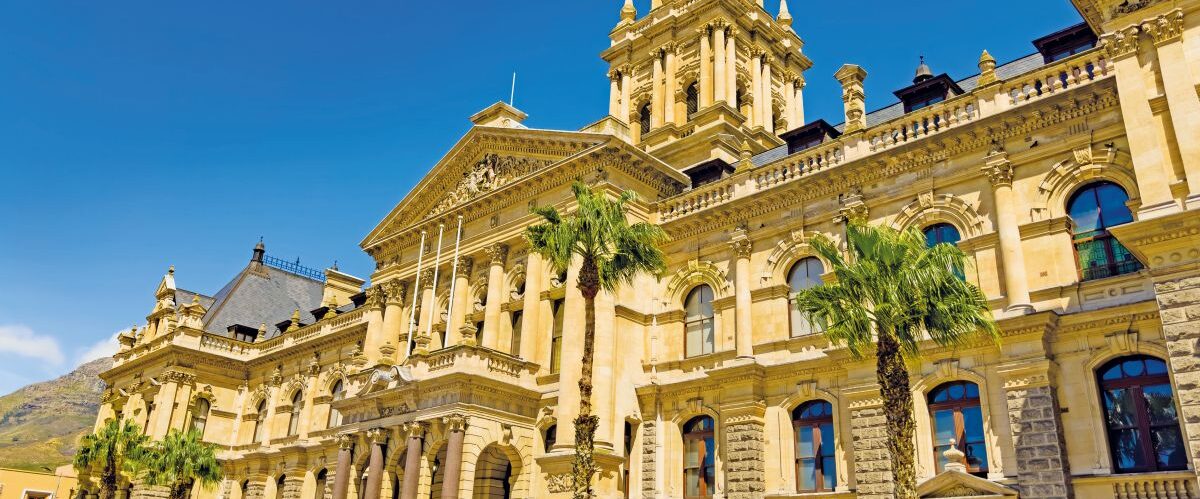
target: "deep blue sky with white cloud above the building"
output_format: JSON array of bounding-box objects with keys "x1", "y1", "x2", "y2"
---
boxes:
[{"x1": 0, "y1": 0, "x2": 1079, "y2": 393}]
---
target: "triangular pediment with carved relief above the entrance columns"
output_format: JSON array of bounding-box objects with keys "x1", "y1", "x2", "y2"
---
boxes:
[{"x1": 361, "y1": 126, "x2": 608, "y2": 248}]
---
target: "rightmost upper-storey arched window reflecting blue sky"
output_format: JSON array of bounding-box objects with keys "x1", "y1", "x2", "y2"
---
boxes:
[{"x1": 1067, "y1": 182, "x2": 1141, "y2": 281}]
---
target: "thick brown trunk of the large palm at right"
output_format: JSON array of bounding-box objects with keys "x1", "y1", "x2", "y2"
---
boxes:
[{"x1": 876, "y1": 329, "x2": 917, "y2": 499}]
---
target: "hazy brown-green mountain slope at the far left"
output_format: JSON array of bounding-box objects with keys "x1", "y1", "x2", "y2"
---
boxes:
[{"x1": 0, "y1": 357, "x2": 113, "y2": 470}]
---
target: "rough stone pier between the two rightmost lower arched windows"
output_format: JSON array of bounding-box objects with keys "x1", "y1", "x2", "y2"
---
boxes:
[{"x1": 998, "y1": 360, "x2": 1072, "y2": 499}]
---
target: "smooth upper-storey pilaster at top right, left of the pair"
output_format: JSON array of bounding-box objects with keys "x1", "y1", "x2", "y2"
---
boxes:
[{"x1": 1100, "y1": 26, "x2": 1176, "y2": 214}]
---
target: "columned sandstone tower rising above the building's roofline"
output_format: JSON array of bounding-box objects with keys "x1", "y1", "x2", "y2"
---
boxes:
[{"x1": 601, "y1": 0, "x2": 812, "y2": 168}]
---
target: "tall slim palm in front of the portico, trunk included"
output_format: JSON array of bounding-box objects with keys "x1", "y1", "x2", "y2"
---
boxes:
[{"x1": 524, "y1": 181, "x2": 667, "y2": 499}]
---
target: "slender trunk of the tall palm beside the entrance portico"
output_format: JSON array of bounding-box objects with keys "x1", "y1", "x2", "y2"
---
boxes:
[{"x1": 571, "y1": 258, "x2": 600, "y2": 499}]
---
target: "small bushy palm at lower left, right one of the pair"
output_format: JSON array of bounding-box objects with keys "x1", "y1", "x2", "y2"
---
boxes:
[{"x1": 140, "y1": 429, "x2": 222, "y2": 499}]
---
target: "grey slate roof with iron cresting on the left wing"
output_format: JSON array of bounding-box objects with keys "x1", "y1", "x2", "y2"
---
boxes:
[{"x1": 200, "y1": 261, "x2": 324, "y2": 339}]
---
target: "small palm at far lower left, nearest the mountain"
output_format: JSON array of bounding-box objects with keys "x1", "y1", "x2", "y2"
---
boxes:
[{"x1": 73, "y1": 420, "x2": 149, "y2": 499}]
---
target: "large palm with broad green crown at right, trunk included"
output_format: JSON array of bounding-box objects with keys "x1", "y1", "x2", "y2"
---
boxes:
[{"x1": 796, "y1": 223, "x2": 998, "y2": 499}]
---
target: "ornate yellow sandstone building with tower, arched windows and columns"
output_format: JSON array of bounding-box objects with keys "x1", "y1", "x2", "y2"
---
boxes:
[{"x1": 97, "y1": 0, "x2": 1200, "y2": 499}]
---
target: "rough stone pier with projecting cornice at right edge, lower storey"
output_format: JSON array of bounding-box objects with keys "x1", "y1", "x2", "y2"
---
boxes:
[{"x1": 1112, "y1": 209, "x2": 1200, "y2": 470}]
